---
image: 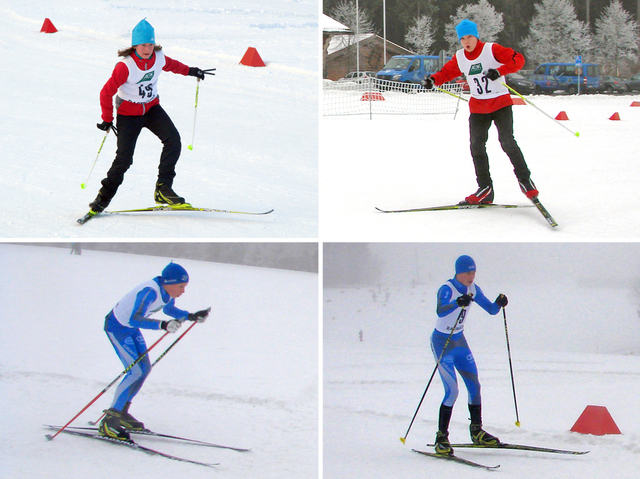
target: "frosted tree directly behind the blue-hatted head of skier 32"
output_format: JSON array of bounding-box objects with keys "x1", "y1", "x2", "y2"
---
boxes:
[{"x1": 445, "y1": 0, "x2": 504, "y2": 53}]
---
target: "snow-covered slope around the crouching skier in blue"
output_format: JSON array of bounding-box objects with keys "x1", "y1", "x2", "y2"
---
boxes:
[{"x1": 0, "y1": 244, "x2": 318, "y2": 479}]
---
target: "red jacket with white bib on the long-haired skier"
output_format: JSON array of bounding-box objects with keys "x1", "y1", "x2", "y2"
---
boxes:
[{"x1": 100, "y1": 51, "x2": 189, "y2": 122}]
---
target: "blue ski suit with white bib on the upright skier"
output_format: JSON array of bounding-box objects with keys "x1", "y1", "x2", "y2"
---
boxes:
[{"x1": 431, "y1": 278, "x2": 500, "y2": 407}]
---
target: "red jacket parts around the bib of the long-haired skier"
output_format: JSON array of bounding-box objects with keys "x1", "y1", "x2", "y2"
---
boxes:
[{"x1": 100, "y1": 52, "x2": 189, "y2": 122}]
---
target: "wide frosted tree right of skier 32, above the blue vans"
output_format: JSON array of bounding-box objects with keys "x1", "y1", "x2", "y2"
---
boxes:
[{"x1": 522, "y1": 0, "x2": 591, "y2": 65}]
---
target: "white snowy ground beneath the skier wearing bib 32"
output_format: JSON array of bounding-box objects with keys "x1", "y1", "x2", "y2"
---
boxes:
[{"x1": 320, "y1": 95, "x2": 640, "y2": 241}]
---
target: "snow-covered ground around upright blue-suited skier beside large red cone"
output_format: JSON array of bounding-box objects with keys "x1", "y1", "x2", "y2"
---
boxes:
[{"x1": 323, "y1": 243, "x2": 640, "y2": 479}]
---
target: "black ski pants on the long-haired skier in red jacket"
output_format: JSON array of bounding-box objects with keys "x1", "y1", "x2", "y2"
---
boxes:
[{"x1": 100, "y1": 105, "x2": 182, "y2": 200}]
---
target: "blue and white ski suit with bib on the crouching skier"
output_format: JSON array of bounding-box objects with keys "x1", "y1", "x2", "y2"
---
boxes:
[{"x1": 104, "y1": 276, "x2": 189, "y2": 411}]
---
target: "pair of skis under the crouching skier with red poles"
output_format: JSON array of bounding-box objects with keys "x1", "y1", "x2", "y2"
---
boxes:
[{"x1": 45, "y1": 425, "x2": 250, "y2": 467}]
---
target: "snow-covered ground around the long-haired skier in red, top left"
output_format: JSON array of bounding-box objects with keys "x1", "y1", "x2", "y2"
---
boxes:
[{"x1": 0, "y1": 0, "x2": 320, "y2": 238}]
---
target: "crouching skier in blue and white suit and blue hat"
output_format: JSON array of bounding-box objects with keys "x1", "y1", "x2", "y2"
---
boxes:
[{"x1": 99, "y1": 262, "x2": 211, "y2": 440}]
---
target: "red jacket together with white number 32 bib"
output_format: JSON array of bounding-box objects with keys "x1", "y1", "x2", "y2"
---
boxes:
[{"x1": 432, "y1": 40, "x2": 525, "y2": 113}]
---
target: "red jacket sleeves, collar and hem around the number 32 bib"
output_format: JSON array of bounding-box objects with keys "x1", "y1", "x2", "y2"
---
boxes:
[{"x1": 432, "y1": 40, "x2": 525, "y2": 113}]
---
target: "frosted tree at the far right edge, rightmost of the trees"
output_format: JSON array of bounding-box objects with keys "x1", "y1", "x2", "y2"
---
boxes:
[{"x1": 594, "y1": 0, "x2": 638, "y2": 75}]
